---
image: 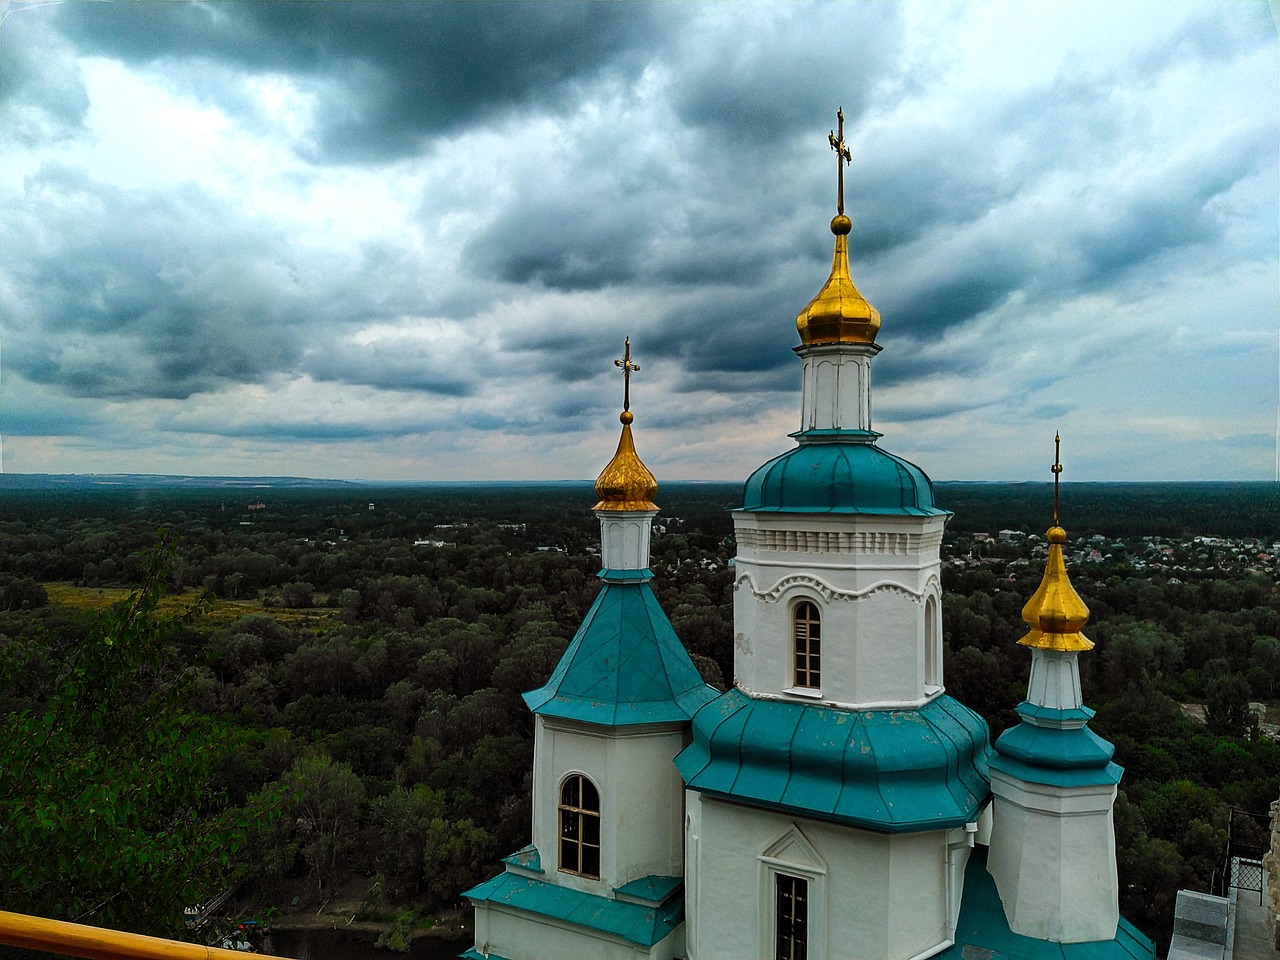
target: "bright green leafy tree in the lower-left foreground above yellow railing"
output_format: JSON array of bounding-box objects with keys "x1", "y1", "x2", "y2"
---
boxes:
[{"x1": 0, "y1": 552, "x2": 262, "y2": 934}]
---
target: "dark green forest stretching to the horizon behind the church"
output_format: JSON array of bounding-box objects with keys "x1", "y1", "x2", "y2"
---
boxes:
[{"x1": 0, "y1": 479, "x2": 1280, "y2": 948}]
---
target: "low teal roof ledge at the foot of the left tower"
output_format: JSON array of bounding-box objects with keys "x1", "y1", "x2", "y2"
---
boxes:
[{"x1": 462, "y1": 873, "x2": 685, "y2": 947}]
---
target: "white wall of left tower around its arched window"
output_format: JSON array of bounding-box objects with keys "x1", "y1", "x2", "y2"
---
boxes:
[{"x1": 529, "y1": 714, "x2": 687, "y2": 896}]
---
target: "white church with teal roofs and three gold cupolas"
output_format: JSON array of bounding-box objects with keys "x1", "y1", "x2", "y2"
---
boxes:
[{"x1": 463, "y1": 116, "x2": 1155, "y2": 960}]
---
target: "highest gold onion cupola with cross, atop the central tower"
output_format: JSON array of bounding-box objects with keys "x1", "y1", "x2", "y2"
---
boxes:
[{"x1": 796, "y1": 109, "x2": 879, "y2": 346}]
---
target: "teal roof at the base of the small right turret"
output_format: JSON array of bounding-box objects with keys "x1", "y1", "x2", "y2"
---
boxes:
[{"x1": 937, "y1": 847, "x2": 1156, "y2": 960}]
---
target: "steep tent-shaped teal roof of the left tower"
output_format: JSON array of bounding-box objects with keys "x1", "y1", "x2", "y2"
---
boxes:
[{"x1": 525, "y1": 581, "x2": 717, "y2": 727}]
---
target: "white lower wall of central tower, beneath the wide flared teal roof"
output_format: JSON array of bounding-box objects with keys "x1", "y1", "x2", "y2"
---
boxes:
[{"x1": 685, "y1": 791, "x2": 972, "y2": 960}]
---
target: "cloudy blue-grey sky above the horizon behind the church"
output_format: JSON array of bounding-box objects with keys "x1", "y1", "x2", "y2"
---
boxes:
[{"x1": 0, "y1": 0, "x2": 1280, "y2": 483}]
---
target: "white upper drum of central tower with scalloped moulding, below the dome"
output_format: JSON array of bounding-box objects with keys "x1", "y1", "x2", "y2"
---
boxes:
[{"x1": 733, "y1": 511, "x2": 946, "y2": 708}]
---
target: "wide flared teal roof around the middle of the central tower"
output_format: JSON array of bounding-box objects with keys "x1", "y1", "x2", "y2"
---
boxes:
[{"x1": 676, "y1": 690, "x2": 991, "y2": 832}]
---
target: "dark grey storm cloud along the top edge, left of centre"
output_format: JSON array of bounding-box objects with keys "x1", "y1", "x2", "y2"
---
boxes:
[{"x1": 45, "y1": 0, "x2": 685, "y2": 163}]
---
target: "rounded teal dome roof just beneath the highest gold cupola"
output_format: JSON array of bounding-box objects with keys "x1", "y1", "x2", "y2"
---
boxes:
[{"x1": 742, "y1": 440, "x2": 947, "y2": 517}]
